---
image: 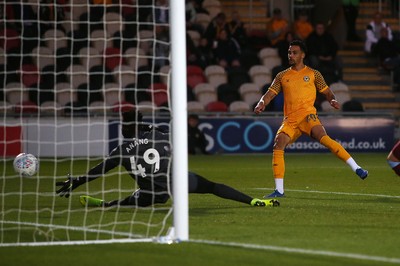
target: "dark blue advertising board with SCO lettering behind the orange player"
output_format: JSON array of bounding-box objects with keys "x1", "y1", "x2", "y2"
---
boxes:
[{"x1": 109, "y1": 117, "x2": 395, "y2": 154}]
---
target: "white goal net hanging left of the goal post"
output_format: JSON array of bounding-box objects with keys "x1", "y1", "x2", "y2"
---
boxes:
[{"x1": 0, "y1": 0, "x2": 187, "y2": 246}]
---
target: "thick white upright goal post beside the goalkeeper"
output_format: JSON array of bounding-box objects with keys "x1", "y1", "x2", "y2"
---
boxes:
[{"x1": 171, "y1": 0, "x2": 189, "y2": 241}]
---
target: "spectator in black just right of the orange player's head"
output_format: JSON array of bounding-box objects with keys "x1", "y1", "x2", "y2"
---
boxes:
[{"x1": 306, "y1": 23, "x2": 343, "y2": 84}]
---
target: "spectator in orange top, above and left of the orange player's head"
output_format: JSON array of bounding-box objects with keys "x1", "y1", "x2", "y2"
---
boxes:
[{"x1": 267, "y1": 8, "x2": 289, "y2": 46}]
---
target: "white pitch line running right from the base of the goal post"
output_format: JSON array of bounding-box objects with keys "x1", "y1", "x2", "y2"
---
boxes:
[{"x1": 189, "y1": 239, "x2": 400, "y2": 264}]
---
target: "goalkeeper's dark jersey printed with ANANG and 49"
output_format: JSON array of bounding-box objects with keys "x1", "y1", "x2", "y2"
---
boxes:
[{"x1": 89, "y1": 129, "x2": 171, "y2": 191}]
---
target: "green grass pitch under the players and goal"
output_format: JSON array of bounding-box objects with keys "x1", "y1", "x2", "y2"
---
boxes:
[{"x1": 0, "y1": 152, "x2": 400, "y2": 266}]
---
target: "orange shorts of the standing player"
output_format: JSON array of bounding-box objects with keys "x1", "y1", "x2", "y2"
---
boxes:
[{"x1": 276, "y1": 114, "x2": 322, "y2": 143}]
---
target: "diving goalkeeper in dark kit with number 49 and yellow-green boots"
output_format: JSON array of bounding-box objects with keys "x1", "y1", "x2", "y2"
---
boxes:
[{"x1": 56, "y1": 110, "x2": 279, "y2": 207}]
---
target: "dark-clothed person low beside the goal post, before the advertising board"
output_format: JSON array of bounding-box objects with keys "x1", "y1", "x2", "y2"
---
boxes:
[{"x1": 188, "y1": 115, "x2": 208, "y2": 154}]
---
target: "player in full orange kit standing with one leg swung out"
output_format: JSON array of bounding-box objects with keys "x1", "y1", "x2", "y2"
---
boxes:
[{"x1": 254, "y1": 40, "x2": 368, "y2": 197}]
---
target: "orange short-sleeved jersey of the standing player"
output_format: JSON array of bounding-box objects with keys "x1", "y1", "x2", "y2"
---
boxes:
[{"x1": 269, "y1": 66, "x2": 328, "y2": 118}]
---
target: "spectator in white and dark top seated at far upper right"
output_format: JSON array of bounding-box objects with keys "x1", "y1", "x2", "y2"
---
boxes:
[{"x1": 364, "y1": 12, "x2": 393, "y2": 54}]
